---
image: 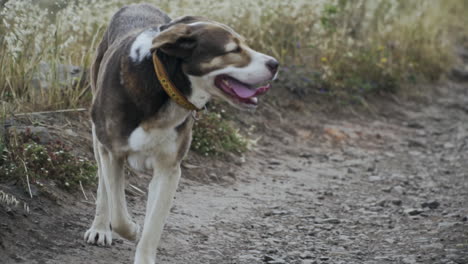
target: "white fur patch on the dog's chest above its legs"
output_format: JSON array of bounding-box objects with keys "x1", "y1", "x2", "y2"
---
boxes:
[{"x1": 127, "y1": 127, "x2": 178, "y2": 174}]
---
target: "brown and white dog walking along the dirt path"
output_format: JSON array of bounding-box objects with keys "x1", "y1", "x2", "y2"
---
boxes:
[{"x1": 84, "y1": 4, "x2": 278, "y2": 264}]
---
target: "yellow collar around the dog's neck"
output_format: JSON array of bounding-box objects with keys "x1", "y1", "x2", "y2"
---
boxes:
[{"x1": 153, "y1": 52, "x2": 200, "y2": 110}]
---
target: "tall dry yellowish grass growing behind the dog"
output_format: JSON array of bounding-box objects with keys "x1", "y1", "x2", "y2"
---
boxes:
[{"x1": 0, "y1": 0, "x2": 468, "y2": 112}]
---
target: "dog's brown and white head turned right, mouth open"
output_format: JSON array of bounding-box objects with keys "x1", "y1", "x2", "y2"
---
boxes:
[{"x1": 151, "y1": 16, "x2": 279, "y2": 109}]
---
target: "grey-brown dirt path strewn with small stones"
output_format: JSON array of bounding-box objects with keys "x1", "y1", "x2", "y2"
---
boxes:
[{"x1": 0, "y1": 60, "x2": 468, "y2": 264}]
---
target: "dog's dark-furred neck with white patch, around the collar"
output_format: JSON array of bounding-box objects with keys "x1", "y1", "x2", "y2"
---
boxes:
[{"x1": 120, "y1": 28, "x2": 210, "y2": 134}]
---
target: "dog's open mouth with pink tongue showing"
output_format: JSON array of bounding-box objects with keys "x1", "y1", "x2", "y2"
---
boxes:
[{"x1": 215, "y1": 75, "x2": 271, "y2": 106}]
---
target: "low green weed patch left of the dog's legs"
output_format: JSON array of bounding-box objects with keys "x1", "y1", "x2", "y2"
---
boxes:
[{"x1": 0, "y1": 130, "x2": 96, "y2": 190}]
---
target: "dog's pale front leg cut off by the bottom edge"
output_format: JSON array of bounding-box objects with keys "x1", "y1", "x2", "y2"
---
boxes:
[{"x1": 135, "y1": 164, "x2": 180, "y2": 264}]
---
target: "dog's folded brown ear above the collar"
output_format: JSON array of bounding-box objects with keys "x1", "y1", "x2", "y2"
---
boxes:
[{"x1": 151, "y1": 24, "x2": 197, "y2": 58}]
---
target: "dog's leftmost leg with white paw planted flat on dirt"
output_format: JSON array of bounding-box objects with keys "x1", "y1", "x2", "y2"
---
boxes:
[{"x1": 84, "y1": 125, "x2": 112, "y2": 246}]
